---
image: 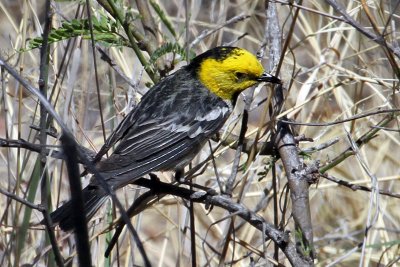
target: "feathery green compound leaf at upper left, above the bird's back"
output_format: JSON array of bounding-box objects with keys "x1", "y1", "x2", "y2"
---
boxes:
[{"x1": 23, "y1": 16, "x2": 129, "y2": 51}]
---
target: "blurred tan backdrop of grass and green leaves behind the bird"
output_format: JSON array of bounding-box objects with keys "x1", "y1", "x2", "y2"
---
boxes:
[{"x1": 0, "y1": 0, "x2": 400, "y2": 266}]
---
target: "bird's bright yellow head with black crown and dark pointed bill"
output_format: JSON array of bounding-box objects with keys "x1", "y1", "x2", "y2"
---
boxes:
[{"x1": 189, "y1": 47, "x2": 280, "y2": 100}]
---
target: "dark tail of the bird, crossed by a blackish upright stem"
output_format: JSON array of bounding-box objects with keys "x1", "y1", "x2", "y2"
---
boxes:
[{"x1": 50, "y1": 186, "x2": 107, "y2": 231}]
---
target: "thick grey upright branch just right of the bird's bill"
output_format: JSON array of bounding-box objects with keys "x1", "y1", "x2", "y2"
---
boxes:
[{"x1": 267, "y1": 1, "x2": 315, "y2": 263}]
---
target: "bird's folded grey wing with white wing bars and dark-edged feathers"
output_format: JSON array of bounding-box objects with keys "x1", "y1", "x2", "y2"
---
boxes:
[{"x1": 98, "y1": 105, "x2": 230, "y2": 185}]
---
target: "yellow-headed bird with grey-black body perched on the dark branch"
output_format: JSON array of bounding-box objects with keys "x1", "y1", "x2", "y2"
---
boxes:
[{"x1": 50, "y1": 46, "x2": 281, "y2": 231}]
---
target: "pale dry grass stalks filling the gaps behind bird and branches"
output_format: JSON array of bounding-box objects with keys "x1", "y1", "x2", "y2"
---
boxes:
[{"x1": 0, "y1": 0, "x2": 400, "y2": 266}]
